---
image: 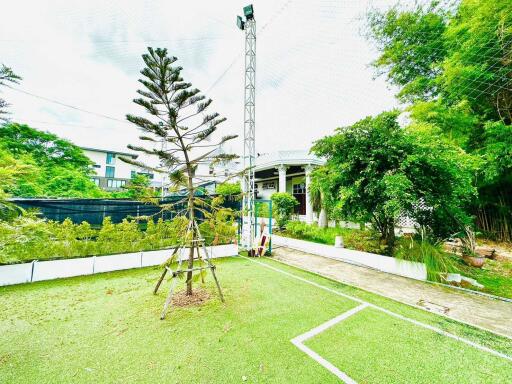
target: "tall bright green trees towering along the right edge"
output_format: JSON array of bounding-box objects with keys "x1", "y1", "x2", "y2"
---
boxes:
[{"x1": 368, "y1": 0, "x2": 512, "y2": 241}]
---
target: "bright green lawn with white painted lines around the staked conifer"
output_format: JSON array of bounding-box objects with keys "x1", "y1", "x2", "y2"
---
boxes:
[{"x1": 0, "y1": 258, "x2": 512, "y2": 384}]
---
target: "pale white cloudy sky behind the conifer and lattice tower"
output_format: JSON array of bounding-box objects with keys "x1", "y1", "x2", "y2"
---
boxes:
[{"x1": 0, "y1": 0, "x2": 398, "y2": 159}]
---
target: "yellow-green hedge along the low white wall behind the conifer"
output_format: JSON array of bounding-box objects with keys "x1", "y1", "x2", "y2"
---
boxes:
[{"x1": 0, "y1": 212, "x2": 236, "y2": 264}]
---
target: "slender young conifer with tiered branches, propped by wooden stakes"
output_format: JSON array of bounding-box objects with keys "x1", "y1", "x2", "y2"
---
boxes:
[{"x1": 121, "y1": 48, "x2": 237, "y2": 295}]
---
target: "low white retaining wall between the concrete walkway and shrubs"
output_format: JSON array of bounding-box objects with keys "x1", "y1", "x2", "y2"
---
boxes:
[{"x1": 272, "y1": 235, "x2": 427, "y2": 280}]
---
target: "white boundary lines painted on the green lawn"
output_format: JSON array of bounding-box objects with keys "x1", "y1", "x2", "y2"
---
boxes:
[{"x1": 240, "y1": 256, "x2": 512, "y2": 383}]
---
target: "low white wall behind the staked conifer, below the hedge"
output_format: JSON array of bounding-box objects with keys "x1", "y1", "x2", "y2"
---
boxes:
[{"x1": 0, "y1": 244, "x2": 238, "y2": 286}]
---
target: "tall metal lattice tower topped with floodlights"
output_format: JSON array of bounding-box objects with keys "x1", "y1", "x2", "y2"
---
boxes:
[{"x1": 238, "y1": 5, "x2": 256, "y2": 250}]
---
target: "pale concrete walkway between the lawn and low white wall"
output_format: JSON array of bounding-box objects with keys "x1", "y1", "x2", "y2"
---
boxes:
[{"x1": 273, "y1": 247, "x2": 512, "y2": 339}]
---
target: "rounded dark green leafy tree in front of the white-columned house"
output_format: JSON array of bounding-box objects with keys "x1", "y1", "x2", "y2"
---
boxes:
[{"x1": 312, "y1": 111, "x2": 476, "y2": 246}]
